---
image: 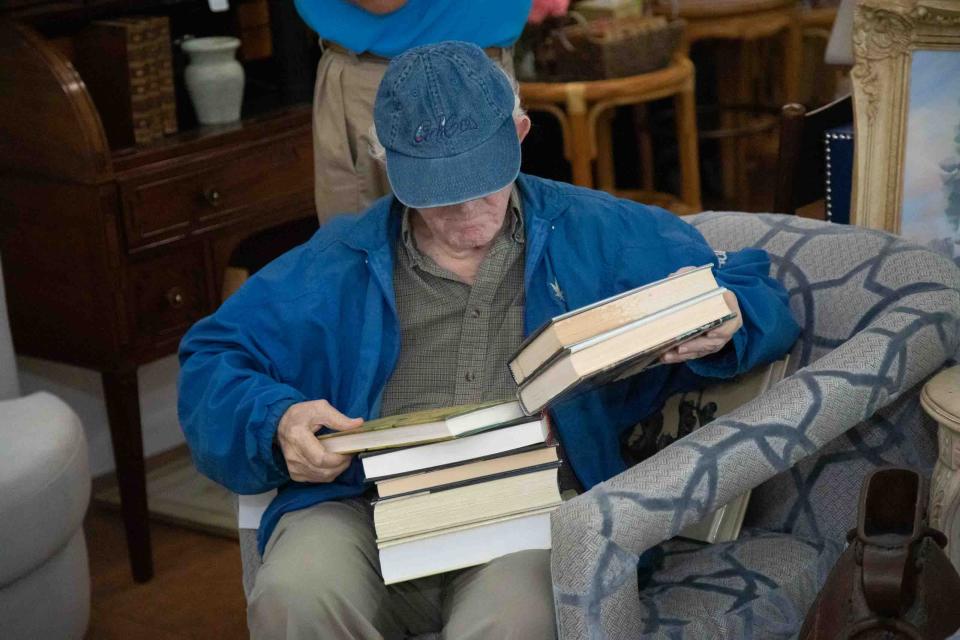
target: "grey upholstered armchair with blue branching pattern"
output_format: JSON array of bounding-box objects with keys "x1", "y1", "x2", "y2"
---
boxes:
[{"x1": 552, "y1": 213, "x2": 960, "y2": 639}]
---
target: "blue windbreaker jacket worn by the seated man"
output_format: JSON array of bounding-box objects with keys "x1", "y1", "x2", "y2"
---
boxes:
[{"x1": 178, "y1": 174, "x2": 799, "y2": 552}]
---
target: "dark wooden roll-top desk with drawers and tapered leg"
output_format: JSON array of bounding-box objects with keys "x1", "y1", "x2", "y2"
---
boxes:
[{"x1": 0, "y1": 19, "x2": 315, "y2": 581}]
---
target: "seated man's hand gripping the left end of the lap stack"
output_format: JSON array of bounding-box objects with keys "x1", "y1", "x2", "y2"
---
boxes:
[{"x1": 277, "y1": 400, "x2": 363, "y2": 482}]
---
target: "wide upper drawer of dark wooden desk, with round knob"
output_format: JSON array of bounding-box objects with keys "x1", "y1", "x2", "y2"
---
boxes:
[{"x1": 120, "y1": 136, "x2": 313, "y2": 249}]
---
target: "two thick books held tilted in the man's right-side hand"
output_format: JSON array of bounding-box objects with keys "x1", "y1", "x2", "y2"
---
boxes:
[{"x1": 509, "y1": 265, "x2": 735, "y2": 413}]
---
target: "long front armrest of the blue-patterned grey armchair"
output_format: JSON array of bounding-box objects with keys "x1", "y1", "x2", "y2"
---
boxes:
[{"x1": 551, "y1": 286, "x2": 960, "y2": 638}]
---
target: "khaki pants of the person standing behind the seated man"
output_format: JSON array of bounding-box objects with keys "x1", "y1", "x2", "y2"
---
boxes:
[{"x1": 313, "y1": 49, "x2": 513, "y2": 223}]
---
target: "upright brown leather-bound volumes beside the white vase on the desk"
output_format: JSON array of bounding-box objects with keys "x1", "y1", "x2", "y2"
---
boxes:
[{"x1": 74, "y1": 16, "x2": 177, "y2": 149}]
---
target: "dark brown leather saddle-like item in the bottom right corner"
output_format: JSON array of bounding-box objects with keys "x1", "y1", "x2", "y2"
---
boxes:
[{"x1": 799, "y1": 468, "x2": 960, "y2": 640}]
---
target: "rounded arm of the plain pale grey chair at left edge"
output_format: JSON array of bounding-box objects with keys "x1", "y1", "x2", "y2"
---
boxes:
[{"x1": 0, "y1": 392, "x2": 90, "y2": 587}]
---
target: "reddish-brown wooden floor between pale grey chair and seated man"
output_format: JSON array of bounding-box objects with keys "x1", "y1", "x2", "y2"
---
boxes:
[{"x1": 84, "y1": 505, "x2": 248, "y2": 640}]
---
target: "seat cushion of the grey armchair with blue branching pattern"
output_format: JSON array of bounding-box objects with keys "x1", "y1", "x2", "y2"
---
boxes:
[{"x1": 637, "y1": 530, "x2": 841, "y2": 639}]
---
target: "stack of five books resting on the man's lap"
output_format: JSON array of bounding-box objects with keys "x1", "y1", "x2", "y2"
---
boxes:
[{"x1": 319, "y1": 401, "x2": 561, "y2": 584}]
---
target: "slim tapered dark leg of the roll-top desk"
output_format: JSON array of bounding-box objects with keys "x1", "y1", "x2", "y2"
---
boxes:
[{"x1": 102, "y1": 367, "x2": 153, "y2": 582}]
